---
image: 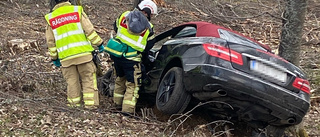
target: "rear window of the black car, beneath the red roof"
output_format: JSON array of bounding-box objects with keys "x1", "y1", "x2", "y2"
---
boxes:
[{"x1": 218, "y1": 29, "x2": 264, "y2": 49}]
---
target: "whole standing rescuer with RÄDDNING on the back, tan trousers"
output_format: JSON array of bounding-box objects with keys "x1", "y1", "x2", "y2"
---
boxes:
[{"x1": 45, "y1": 0, "x2": 104, "y2": 108}]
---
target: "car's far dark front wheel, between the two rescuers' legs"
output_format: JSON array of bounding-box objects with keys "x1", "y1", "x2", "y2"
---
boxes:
[{"x1": 98, "y1": 69, "x2": 115, "y2": 97}]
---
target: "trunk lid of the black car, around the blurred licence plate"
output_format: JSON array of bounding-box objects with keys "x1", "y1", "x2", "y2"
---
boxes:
[{"x1": 228, "y1": 43, "x2": 304, "y2": 86}]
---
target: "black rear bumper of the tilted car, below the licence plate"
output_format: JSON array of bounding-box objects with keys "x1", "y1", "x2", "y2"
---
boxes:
[{"x1": 184, "y1": 64, "x2": 310, "y2": 125}]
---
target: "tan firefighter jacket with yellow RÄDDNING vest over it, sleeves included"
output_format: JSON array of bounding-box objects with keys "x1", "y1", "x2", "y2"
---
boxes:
[{"x1": 45, "y1": 2, "x2": 103, "y2": 67}]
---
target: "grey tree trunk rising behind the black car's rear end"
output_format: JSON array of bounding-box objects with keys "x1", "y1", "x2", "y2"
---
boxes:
[{"x1": 279, "y1": 0, "x2": 307, "y2": 66}]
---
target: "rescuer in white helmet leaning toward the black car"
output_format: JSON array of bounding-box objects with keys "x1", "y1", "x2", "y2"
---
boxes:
[{"x1": 105, "y1": 0, "x2": 157, "y2": 114}]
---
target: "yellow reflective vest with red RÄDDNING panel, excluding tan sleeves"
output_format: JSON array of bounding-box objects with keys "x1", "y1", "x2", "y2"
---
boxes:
[{"x1": 45, "y1": 6, "x2": 96, "y2": 61}]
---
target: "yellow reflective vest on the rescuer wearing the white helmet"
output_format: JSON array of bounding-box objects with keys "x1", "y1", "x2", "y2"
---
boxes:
[{"x1": 116, "y1": 11, "x2": 153, "y2": 53}]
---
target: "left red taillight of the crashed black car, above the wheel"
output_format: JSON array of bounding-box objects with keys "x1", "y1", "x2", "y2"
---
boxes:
[{"x1": 203, "y1": 44, "x2": 243, "y2": 65}]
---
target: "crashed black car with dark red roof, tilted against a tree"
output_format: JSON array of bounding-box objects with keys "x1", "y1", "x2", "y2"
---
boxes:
[{"x1": 99, "y1": 22, "x2": 310, "y2": 132}]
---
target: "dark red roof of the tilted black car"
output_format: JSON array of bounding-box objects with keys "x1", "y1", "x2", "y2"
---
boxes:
[{"x1": 179, "y1": 21, "x2": 271, "y2": 51}]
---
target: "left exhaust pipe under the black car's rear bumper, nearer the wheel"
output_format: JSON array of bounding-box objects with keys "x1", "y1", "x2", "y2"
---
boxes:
[{"x1": 193, "y1": 89, "x2": 227, "y2": 100}]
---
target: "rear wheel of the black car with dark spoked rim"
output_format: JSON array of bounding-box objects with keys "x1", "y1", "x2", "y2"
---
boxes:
[{"x1": 156, "y1": 67, "x2": 191, "y2": 115}]
